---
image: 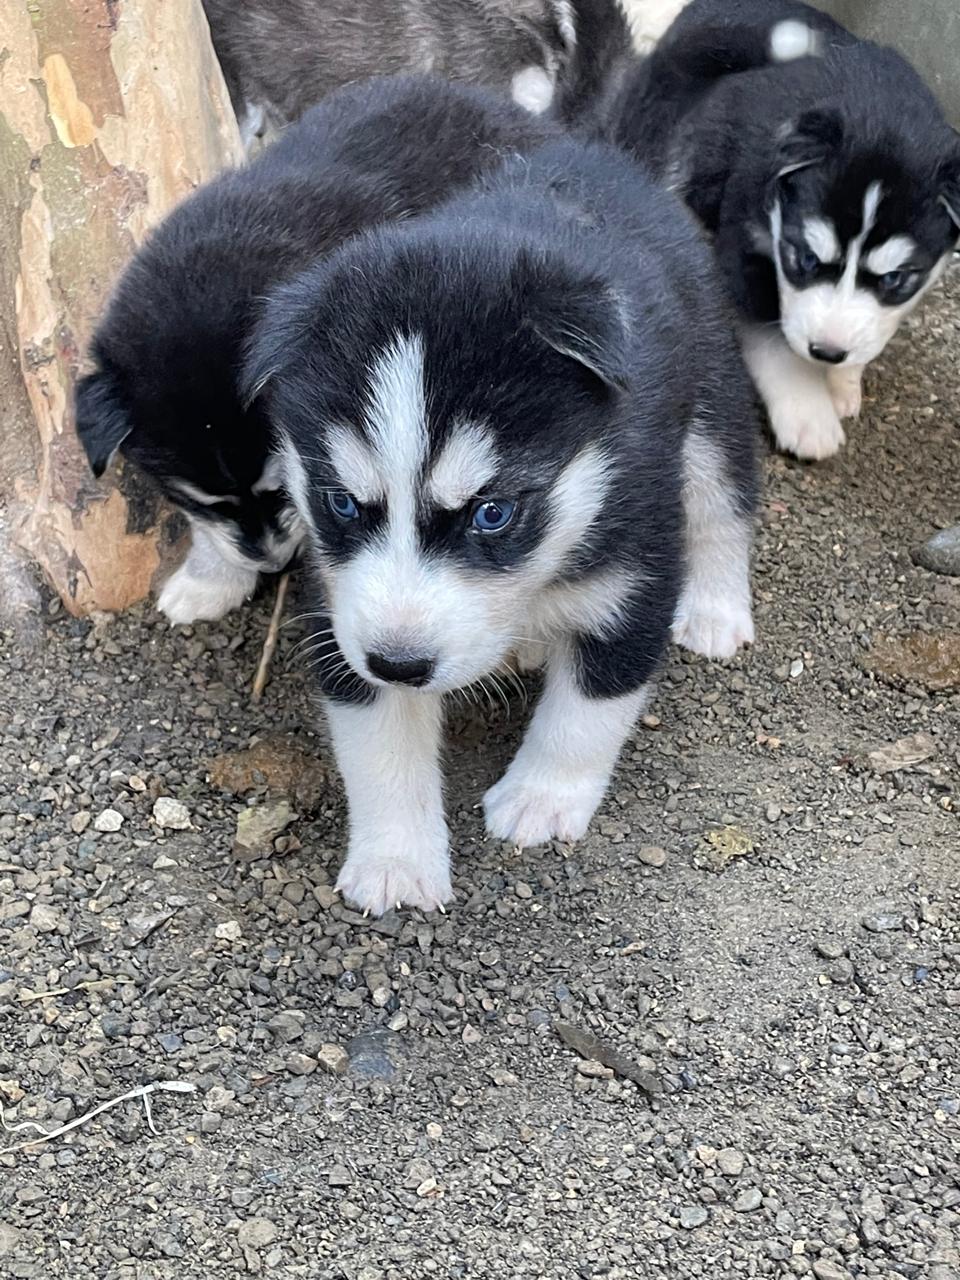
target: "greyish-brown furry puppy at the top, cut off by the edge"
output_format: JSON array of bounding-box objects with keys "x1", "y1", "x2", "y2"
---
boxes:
[{"x1": 204, "y1": 0, "x2": 591, "y2": 141}]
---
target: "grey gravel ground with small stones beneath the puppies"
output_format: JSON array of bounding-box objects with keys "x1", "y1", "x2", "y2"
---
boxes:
[{"x1": 0, "y1": 273, "x2": 960, "y2": 1280}]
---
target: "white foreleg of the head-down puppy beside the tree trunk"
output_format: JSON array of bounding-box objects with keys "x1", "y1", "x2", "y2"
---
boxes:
[{"x1": 156, "y1": 517, "x2": 257, "y2": 626}]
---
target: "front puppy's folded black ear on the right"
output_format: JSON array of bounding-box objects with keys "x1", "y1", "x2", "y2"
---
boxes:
[{"x1": 526, "y1": 272, "x2": 630, "y2": 392}]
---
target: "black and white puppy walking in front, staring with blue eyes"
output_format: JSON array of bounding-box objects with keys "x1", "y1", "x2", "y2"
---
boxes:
[{"x1": 246, "y1": 140, "x2": 756, "y2": 911}]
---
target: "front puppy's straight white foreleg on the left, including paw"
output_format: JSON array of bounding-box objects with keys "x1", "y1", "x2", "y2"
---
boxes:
[{"x1": 326, "y1": 689, "x2": 452, "y2": 915}]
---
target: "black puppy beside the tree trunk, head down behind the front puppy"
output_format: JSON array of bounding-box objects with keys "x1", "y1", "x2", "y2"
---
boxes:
[{"x1": 77, "y1": 77, "x2": 554, "y2": 622}]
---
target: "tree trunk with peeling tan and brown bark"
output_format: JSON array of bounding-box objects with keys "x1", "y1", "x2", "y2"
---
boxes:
[{"x1": 0, "y1": 0, "x2": 242, "y2": 614}]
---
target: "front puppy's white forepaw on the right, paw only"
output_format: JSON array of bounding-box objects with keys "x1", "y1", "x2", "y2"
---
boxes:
[{"x1": 484, "y1": 762, "x2": 608, "y2": 849}]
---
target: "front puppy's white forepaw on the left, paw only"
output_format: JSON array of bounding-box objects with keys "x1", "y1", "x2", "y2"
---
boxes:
[{"x1": 337, "y1": 840, "x2": 453, "y2": 915}]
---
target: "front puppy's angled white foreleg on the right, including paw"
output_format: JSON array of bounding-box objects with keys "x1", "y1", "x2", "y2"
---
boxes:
[{"x1": 484, "y1": 645, "x2": 648, "y2": 846}]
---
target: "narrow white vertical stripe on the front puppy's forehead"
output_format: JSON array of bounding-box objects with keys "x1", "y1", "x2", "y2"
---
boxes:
[{"x1": 365, "y1": 335, "x2": 428, "y2": 500}]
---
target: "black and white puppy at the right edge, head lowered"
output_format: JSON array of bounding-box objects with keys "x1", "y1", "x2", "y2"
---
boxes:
[{"x1": 607, "y1": 0, "x2": 960, "y2": 458}]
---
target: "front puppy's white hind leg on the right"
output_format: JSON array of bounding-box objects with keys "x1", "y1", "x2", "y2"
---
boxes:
[{"x1": 673, "y1": 426, "x2": 754, "y2": 658}]
